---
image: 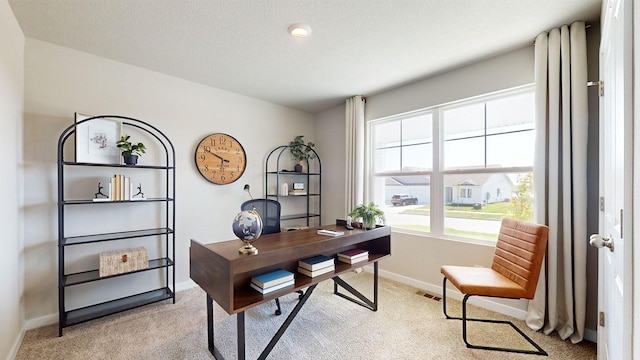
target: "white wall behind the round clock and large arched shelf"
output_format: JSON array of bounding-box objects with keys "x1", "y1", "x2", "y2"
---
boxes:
[{"x1": 24, "y1": 38, "x2": 315, "y2": 326}]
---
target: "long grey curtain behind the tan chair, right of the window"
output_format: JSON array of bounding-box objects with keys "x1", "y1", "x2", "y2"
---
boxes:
[{"x1": 526, "y1": 22, "x2": 588, "y2": 343}]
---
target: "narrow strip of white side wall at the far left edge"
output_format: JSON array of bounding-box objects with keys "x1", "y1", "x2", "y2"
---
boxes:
[{"x1": 0, "y1": 1, "x2": 25, "y2": 359}]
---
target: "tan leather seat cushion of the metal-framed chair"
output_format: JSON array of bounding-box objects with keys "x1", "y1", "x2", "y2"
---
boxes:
[{"x1": 440, "y1": 265, "x2": 526, "y2": 298}]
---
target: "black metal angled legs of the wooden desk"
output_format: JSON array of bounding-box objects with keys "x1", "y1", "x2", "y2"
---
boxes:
[{"x1": 207, "y1": 261, "x2": 378, "y2": 360}]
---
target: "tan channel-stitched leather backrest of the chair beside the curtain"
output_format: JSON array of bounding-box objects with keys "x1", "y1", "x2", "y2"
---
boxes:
[{"x1": 491, "y1": 218, "x2": 549, "y2": 299}]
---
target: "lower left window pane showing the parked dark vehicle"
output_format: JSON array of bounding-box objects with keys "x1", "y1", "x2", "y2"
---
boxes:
[{"x1": 376, "y1": 175, "x2": 431, "y2": 232}]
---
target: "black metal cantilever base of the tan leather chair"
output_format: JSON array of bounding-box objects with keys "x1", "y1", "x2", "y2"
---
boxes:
[{"x1": 442, "y1": 276, "x2": 549, "y2": 356}]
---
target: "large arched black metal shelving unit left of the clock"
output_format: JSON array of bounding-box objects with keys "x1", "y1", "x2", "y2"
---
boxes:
[{"x1": 58, "y1": 115, "x2": 176, "y2": 336}]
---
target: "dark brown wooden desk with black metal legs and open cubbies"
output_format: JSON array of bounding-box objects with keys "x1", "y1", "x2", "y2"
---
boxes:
[{"x1": 190, "y1": 222, "x2": 391, "y2": 360}]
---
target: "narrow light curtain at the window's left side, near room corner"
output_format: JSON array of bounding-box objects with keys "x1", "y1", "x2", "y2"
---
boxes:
[{"x1": 344, "y1": 95, "x2": 367, "y2": 214}]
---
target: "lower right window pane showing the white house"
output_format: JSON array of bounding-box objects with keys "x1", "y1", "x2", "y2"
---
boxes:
[{"x1": 443, "y1": 173, "x2": 533, "y2": 240}]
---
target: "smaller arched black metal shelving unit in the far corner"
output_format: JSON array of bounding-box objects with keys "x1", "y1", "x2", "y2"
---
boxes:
[{"x1": 265, "y1": 145, "x2": 322, "y2": 226}]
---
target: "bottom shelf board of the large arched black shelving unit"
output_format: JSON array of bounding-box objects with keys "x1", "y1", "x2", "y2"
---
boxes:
[{"x1": 63, "y1": 287, "x2": 175, "y2": 326}]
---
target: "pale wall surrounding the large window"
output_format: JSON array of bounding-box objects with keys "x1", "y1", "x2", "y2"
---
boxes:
[{"x1": 316, "y1": 38, "x2": 599, "y2": 329}]
